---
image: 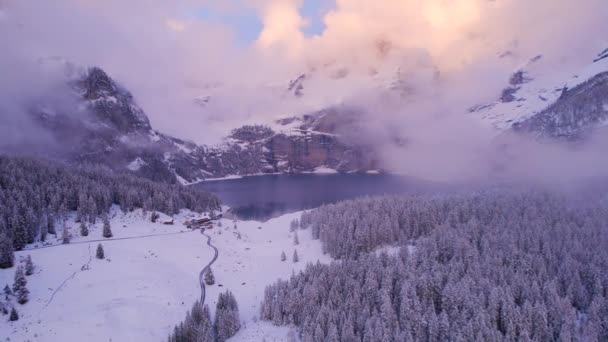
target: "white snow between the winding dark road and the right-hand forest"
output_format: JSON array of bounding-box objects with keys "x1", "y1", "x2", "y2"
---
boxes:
[{"x1": 207, "y1": 213, "x2": 331, "y2": 342}]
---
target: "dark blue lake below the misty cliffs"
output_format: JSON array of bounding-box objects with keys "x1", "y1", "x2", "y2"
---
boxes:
[{"x1": 193, "y1": 174, "x2": 422, "y2": 220}]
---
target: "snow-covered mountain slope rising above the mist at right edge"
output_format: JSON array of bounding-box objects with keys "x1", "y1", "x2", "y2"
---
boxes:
[{"x1": 471, "y1": 49, "x2": 608, "y2": 139}]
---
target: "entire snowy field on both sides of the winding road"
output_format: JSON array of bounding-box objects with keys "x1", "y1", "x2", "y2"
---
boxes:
[{"x1": 0, "y1": 211, "x2": 330, "y2": 342}]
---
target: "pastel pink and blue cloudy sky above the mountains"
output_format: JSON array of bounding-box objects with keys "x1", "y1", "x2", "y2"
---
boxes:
[{"x1": 0, "y1": 0, "x2": 608, "y2": 142}]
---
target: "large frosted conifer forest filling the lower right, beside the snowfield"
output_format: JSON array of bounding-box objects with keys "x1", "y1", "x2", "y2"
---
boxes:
[{"x1": 261, "y1": 190, "x2": 608, "y2": 342}]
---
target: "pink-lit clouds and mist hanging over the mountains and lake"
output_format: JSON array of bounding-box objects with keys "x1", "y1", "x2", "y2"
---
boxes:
[{"x1": 0, "y1": 0, "x2": 608, "y2": 183}]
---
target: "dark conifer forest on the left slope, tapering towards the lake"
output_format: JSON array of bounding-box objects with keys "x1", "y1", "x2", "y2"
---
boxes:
[{"x1": 0, "y1": 156, "x2": 219, "y2": 268}]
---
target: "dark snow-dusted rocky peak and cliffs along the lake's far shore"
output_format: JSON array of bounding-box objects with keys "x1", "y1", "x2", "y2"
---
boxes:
[{"x1": 31, "y1": 68, "x2": 376, "y2": 184}]
